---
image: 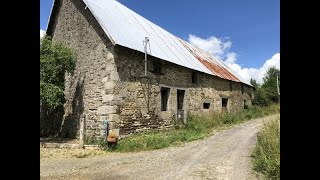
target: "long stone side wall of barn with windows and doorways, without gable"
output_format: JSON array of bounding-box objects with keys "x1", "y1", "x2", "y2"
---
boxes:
[{"x1": 114, "y1": 46, "x2": 251, "y2": 134}]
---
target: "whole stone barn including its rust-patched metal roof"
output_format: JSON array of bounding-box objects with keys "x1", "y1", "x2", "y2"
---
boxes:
[{"x1": 46, "y1": 0, "x2": 253, "y2": 141}]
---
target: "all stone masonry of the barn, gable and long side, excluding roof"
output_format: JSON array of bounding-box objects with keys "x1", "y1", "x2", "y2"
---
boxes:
[{"x1": 47, "y1": 0, "x2": 253, "y2": 138}]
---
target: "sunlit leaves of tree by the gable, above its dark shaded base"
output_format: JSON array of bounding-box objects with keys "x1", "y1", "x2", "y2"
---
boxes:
[{"x1": 40, "y1": 36, "x2": 75, "y2": 109}]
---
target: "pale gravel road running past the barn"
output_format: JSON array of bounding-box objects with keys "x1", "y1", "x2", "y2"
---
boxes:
[{"x1": 40, "y1": 114, "x2": 279, "y2": 180}]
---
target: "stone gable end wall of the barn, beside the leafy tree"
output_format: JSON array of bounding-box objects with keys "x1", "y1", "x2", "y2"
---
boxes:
[{"x1": 52, "y1": 0, "x2": 117, "y2": 137}]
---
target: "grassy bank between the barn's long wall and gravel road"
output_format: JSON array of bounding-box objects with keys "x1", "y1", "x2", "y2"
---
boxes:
[{"x1": 116, "y1": 104, "x2": 280, "y2": 152}]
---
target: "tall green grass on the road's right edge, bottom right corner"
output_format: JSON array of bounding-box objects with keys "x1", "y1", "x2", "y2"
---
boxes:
[{"x1": 252, "y1": 118, "x2": 280, "y2": 179}]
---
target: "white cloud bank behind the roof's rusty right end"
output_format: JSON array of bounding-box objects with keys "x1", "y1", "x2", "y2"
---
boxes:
[{"x1": 188, "y1": 34, "x2": 280, "y2": 84}]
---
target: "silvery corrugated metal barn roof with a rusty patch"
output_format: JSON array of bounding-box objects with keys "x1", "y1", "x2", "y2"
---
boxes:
[{"x1": 83, "y1": 0, "x2": 251, "y2": 86}]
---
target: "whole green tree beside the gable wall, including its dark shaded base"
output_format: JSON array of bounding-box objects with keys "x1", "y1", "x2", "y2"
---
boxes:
[{"x1": 40, "y1": 37, "x2": 76, "y2": 136}]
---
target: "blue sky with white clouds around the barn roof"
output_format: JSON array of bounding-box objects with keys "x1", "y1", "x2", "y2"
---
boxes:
[{"x1": 40, "y1": 0, "x2": 280, "y2": 82}]
